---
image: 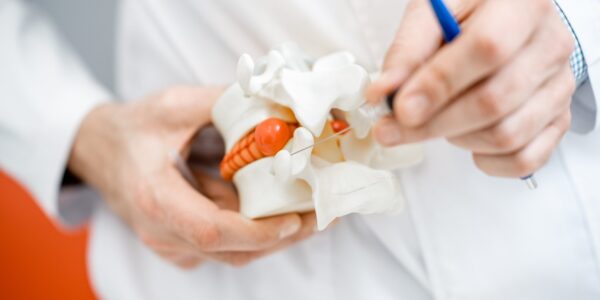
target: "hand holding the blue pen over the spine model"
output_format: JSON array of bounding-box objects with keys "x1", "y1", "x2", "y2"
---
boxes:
[{"x1": 367, "y1": 0, "x2": 575, "y2": 177}]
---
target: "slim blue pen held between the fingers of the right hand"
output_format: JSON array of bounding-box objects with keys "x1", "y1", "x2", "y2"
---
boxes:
[{"x1": 387, "y1": 0, "x2": 537, "y2": 190}]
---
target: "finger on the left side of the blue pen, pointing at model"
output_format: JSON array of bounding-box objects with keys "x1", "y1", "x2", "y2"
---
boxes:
[{"x1": 366, "y1": 0, "x2": 478, "y2": 102}]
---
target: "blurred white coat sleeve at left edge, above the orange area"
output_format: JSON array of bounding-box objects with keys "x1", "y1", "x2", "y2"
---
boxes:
[{"x1": 0, "y1": 0, "x2": 112, "y2": 224}]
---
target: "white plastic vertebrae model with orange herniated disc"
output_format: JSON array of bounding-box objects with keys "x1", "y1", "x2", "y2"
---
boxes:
[{"x1": 212, "y1": 45, "x2": 422, "y2": 229}]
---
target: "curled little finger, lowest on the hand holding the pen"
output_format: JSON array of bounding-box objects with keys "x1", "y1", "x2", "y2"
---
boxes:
[{"x1": 449, "y1": 66, "x2": 575, "y2": 154}]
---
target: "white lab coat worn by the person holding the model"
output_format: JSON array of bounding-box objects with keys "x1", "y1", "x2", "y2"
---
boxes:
[{"x1": 0, "y1": 0, "x2": 600, "y2": 300}]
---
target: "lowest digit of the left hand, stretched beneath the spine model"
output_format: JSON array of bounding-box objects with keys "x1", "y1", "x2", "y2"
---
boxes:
[{"x1": 156, "y1": 167, "x2": 301, "y2": 251}]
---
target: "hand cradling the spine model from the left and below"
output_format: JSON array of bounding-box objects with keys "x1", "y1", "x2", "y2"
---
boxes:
[{"x1": 69, "y1": 87, "x2": 315, "y2": 268}]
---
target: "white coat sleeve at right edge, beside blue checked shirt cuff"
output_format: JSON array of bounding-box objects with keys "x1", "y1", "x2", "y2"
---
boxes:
[{"x1": 556, "y1": 0, "x2": 600, "y2": 133}]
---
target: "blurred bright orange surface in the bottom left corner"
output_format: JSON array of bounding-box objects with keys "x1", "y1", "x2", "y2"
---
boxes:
[{"x1": 0, "y1": 172, "x2": 95, "y2": 299}]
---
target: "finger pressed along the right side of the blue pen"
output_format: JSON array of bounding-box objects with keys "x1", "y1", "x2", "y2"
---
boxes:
[{"x1": 394, "y1": 0, "x2": 551, "y2": 127}]
